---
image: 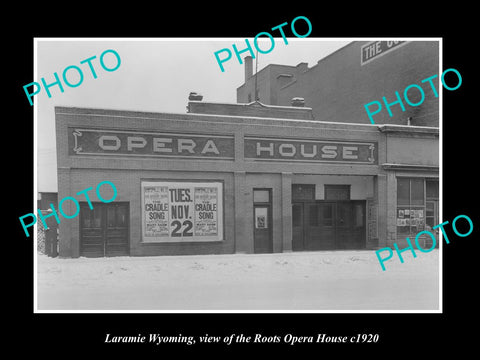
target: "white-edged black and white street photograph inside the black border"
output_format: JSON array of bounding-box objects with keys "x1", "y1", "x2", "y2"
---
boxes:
[{"x1": 32, "y1": 37, "x2": 438, "y2": 312}]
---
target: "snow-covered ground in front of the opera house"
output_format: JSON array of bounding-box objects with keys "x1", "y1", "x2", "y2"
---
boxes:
[{"x1": 37, "y1": 250, "x2": 440, "y2": 311}]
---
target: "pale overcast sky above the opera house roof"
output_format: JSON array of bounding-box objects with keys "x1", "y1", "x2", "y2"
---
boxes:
[{"x1": 34, "y1": 38, "x2": 350, "y2": 192}]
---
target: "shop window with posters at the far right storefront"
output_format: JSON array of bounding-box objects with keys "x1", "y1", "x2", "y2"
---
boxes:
[{"x1": 396, "y1": 178, "x2": 425, "y2": 236}]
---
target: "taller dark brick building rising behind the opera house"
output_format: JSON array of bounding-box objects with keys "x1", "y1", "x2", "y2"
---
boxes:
[{"x1": 237, "y1": 41, "x2": 439, "y2": 127}]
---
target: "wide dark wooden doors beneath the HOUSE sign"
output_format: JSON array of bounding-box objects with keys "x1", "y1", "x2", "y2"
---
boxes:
[{"x1": 292, "y1": 200, "x2": 366, "y2": 251}]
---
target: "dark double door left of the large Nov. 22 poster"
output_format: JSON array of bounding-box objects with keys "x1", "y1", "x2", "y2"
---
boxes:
[{"x1": 80, "y1": 203, "x2": 130, "y2": 257}]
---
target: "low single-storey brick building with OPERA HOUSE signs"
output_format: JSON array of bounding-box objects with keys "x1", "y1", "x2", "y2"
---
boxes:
[{"x1": 55, "y1": 97, "x2": 439, "y2": 257}]
